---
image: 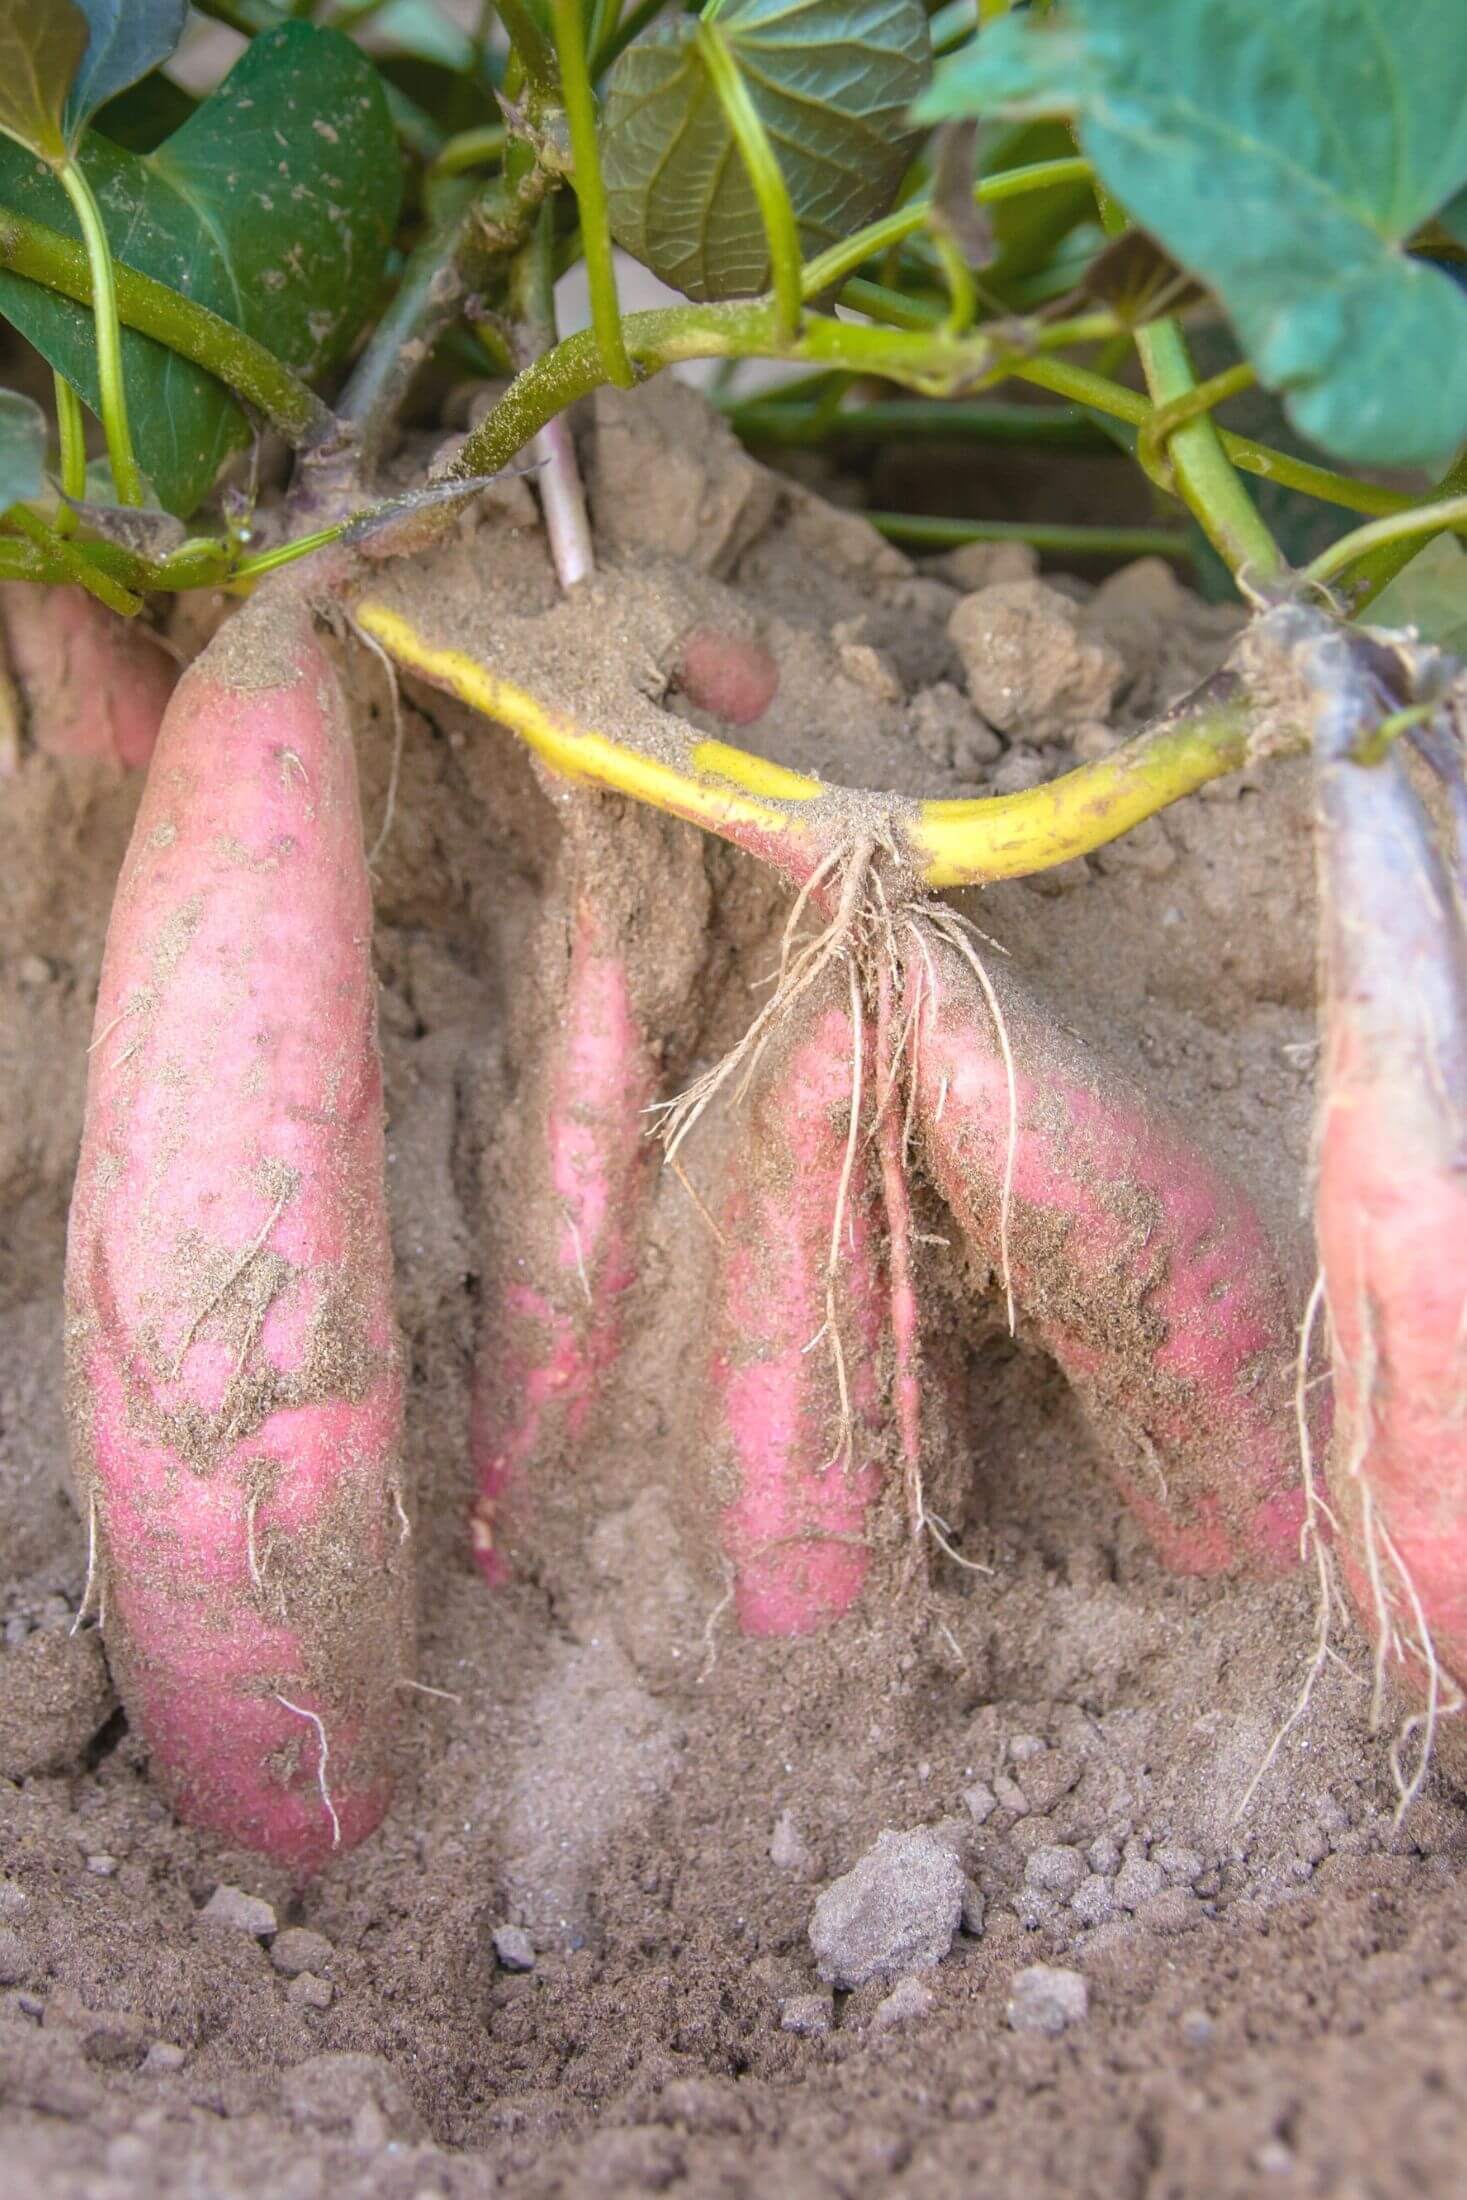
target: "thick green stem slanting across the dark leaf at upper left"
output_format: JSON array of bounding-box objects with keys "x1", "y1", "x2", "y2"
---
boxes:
[{"x1": 0, "y1": 207, "x2": 332, "y2": 444}]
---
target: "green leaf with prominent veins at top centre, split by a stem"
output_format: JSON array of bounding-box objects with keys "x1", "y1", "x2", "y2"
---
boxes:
[{"x1": 600, "y1": 0, "x2": 930, "y2": 299}]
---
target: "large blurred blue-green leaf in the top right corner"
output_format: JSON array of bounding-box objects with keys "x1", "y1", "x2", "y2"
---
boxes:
[{"x1": 917, "y1": 0, "x2": 1467, "y2": 464}]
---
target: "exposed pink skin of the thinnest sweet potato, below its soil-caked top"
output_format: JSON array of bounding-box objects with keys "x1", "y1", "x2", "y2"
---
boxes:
[{"x1": 471, "y1": 895, "x2": 658, "y2": 1584}]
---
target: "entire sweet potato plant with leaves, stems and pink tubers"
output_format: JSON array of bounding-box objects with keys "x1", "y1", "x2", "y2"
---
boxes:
[{"x1": 0, "y1": 0, "x2": 1467, "y2": 1870}]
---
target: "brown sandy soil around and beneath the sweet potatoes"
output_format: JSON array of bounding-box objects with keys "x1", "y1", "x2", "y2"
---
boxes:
[{"x1": 0, "y1": 389, "x2": 1467, "y2": 2200}]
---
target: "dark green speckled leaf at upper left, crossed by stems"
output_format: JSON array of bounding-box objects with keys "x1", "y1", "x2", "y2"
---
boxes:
[{"x1": 0, "y1": 22, "x2": 400, "y2": 517}]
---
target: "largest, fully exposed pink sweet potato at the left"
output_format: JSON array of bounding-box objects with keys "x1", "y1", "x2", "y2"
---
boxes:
[{"x1": 68, "y1": 603, "x2": 407, "y2": 1872}]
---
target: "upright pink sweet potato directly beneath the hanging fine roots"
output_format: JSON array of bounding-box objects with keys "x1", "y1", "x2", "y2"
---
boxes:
[{"x1": 710, "y1": 1008, "x2": 884, "y2": 1635}]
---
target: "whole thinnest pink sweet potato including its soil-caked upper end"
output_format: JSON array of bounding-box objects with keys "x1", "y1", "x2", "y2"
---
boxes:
[{"x1": 471, "y1": 785, "x2": 708, "y2": 1584}]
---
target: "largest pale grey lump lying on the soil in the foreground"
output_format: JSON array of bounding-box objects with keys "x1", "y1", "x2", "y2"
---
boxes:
[{"x1": 809, "y1": 1830, "x2": 966, "y2": 1987}]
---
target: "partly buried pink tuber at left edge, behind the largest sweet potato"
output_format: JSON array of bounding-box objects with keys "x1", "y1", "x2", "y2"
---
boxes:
[{"x1": 0, "y1": 581, "x2": 178, "y2": 770}]
